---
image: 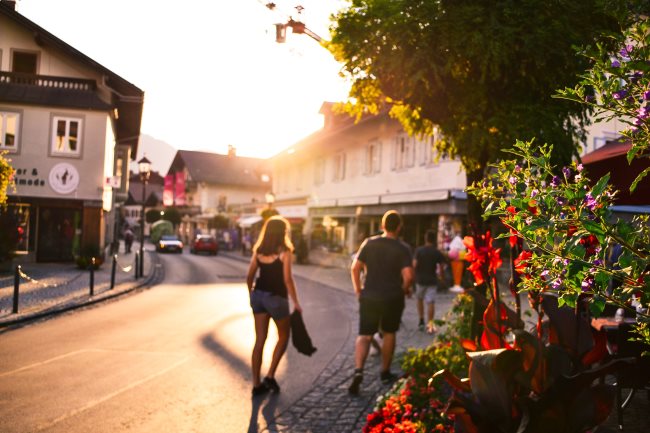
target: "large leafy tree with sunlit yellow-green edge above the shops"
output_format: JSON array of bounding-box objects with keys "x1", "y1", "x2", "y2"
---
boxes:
[{"x1": 328, "y1": 0, "x2": 629, "y2": 226}]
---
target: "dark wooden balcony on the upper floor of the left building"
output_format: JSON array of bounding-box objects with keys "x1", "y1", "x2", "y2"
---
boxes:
[{"x1": 0, "y1": 71, "x2": 111, "y2": 110}]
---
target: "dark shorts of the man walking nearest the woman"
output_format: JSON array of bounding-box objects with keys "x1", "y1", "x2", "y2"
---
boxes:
[{"x1": 359, "y1": 297, "x2": 404, "y2": 335}]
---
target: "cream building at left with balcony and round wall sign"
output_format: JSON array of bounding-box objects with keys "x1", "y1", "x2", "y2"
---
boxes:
[{"x1": 0, "y1": 0, "x2": 144, "y2": 261}]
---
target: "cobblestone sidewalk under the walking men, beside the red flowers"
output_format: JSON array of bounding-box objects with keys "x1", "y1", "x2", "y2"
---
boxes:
[{"x1": 219, "y1": 252, "x2": 456, "y2": 433}]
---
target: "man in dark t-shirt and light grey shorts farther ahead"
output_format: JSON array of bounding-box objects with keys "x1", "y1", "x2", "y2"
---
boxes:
[{"x1": 413, "y1": 230, "x2": 446, "y2": 334}]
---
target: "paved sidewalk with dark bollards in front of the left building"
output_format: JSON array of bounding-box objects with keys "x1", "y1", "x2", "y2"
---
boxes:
[{"x1": 0, "y1": 243, "x2": 160, "y2": 332}]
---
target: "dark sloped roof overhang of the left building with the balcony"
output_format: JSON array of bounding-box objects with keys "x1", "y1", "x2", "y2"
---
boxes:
[{"x1": 0, "y1": 2, "x2": 144, "y2": 154}]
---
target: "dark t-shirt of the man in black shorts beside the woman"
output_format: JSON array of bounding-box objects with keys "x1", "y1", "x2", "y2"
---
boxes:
[{"x1": 357, "y1": 236, "x2": 411, "y2": 300}]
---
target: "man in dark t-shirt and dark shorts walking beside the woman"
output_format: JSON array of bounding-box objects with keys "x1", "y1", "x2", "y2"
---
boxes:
[{"x1": 348, "y1": 210, "x2": 413, "y2": 395}]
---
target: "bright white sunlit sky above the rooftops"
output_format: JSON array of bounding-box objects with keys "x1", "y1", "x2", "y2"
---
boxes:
[{"x1": 16, "y1": 0, "x2": 349, "y2": 158}]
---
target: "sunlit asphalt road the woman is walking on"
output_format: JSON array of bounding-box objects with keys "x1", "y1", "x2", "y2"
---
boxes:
[{"x1": 0, "y1": 252, "x2": 353, "y2": 433}]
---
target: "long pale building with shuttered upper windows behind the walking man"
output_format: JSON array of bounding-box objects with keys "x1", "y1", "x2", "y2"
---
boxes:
[{"x1": 272, "y1": 103, "x2": 467, "y2": 261}]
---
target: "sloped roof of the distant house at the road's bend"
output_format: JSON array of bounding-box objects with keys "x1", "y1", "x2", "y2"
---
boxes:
[{"x1": 169, "y1": 150, "x2": 271, "y2": 187}]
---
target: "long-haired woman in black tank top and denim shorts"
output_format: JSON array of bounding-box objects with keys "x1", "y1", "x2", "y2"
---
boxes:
[{"x1": 246, "y1": 216, "x2": 302, "y2": 396}]
